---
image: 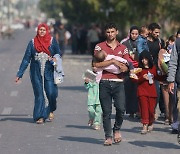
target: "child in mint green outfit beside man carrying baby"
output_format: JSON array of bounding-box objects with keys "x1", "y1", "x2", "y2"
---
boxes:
[{"x1": 84, "y1": 64, "x2": 102, "y2": 130}]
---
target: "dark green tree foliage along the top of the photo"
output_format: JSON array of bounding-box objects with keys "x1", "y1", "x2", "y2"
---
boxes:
[{"x1": 39, "y1": 0, "x2": 180, "y2": 36}]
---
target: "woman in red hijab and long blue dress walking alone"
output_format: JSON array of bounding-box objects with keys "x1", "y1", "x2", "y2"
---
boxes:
[{"x1": 15, "y1": 23, "x2": 60, "y2": 124}]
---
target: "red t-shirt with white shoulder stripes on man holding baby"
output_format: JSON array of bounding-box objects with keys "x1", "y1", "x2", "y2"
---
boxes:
[{"x1": 94, "y1": 41, "x2": 130, "y2": 79}]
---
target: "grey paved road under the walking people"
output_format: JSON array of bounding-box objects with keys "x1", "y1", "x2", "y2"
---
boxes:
[{"x1": 0, "y1": 30, "x2": 180, "y2": 154}]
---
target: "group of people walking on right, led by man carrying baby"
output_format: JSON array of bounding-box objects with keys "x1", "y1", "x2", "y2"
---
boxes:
[{"x1": 85, "y1": 23, "x2": 180, "y2": 146}]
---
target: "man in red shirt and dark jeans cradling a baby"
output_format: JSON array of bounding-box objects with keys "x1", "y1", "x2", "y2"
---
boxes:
[{"x1": 93, "y1": 23, "x2": 129, "y2": 146}]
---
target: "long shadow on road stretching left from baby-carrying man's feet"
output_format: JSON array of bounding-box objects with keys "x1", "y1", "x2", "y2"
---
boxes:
[{"x1": 58, "y1": 136, "x2": 103, "y2": 144}]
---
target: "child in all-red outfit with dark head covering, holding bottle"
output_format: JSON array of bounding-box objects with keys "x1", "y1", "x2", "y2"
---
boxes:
[{"x1": 133, "y1": 51, "x2": 165, "y2": 134}]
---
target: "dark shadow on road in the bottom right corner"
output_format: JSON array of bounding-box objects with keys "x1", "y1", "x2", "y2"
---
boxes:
[{"x1": 129, "y1": 141, "x2": 180, "y2": 149}]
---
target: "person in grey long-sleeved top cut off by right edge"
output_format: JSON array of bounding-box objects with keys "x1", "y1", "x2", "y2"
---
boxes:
[{"x1": 167, "y1": 37, "x2": 180, "y2": 144}]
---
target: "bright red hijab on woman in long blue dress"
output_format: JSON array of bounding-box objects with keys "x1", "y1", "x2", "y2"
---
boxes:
[{"x1": 34, "y1": 23, "x2": 51, "y2": 55}]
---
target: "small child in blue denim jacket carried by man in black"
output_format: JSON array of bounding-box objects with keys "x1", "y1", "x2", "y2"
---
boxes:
[{"x1": 137, "y1": 26, "x2": 149, "y2": 55}]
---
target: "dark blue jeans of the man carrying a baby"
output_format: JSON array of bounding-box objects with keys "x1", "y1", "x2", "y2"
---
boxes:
[{"x1": 99, "y1": 80, "x2": 125, "y2": 138}]
